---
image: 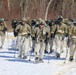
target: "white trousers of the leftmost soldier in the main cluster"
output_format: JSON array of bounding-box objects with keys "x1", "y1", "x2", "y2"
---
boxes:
[{"x1": 19, "y1": 37, "x2": 30, "y2": 57}]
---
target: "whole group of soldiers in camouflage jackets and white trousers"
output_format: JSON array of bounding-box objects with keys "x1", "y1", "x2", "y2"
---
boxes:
[{"x1": 0, "y1": 16, "x2": 76, "y2": 63}]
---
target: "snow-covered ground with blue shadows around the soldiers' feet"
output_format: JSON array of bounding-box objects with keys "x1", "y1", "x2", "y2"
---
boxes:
[{"x1": 0, "y1": 33, "x2": 76, "y2": 75}]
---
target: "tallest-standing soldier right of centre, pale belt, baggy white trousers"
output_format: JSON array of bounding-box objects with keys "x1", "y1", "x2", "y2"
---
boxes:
[{"x1": 54, "y1": 16, "x2": 67, "y2": 58}]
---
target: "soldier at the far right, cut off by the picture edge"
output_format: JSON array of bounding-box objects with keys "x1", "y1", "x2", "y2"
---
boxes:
[{"x1": 69, "y1": 21, "x2": 76, "y2": 61}]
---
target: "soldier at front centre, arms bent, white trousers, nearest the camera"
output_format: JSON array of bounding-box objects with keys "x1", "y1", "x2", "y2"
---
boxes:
[{"x1": 32, "y1": 19, "x2": 50, "y2": 63}]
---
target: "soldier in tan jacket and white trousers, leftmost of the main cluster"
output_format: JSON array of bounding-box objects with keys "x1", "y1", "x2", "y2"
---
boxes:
[{"x1": 15, "y1": 18, "x2": 31, "y2": 59}]
